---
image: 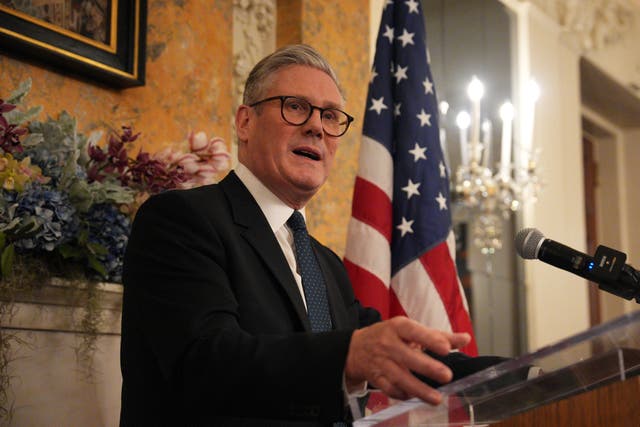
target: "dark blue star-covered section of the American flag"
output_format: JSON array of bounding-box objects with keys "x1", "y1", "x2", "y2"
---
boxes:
[{"x1": 363, "y1": 0, "x2": 451, "y2": 275}]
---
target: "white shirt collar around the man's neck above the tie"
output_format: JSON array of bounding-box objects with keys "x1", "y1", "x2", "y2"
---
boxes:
[{"x1": 234, "y1": 163, "x2": 306, "y2": 233}]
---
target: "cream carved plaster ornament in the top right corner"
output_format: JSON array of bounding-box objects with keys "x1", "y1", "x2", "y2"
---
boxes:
[{"x1": 521, "y1": 0, "x2": 640, "y2": 51}]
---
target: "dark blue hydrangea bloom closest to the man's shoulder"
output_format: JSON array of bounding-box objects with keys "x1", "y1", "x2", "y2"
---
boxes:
[{"x1": 84, "y1": 203, "x2": 131, "y2": 282}]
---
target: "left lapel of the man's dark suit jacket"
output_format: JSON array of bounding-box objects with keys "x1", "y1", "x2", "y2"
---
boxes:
[{"x1": 220, "y1": 171, "x2": 311, "y2": 331}]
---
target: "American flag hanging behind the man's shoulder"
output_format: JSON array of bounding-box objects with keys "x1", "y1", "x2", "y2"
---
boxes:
[{"x1": 344, "y1": 0, "x2": 478, "y2": 356}]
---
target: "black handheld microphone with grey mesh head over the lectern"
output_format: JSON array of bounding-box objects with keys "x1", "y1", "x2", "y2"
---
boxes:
[{"x1": 515, "y1": 228, "x2": 640, "y2": 302}]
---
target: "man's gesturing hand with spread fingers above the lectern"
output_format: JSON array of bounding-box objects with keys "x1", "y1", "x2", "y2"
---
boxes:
[{"x1": 345, "y1": 317, "x2": 471, "y2": 405}]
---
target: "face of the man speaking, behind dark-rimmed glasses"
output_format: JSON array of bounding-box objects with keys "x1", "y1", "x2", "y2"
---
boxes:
[{"x1": 236, "y1": 65, "x2": 342, "y2": 209}]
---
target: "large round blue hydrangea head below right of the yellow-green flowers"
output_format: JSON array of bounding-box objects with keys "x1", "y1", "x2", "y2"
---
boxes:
[{"x1": 16, "y1": 185, "x2": 78, "y2": 252}]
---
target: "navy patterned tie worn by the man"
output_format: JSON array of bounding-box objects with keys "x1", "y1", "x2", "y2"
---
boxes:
[{"x1": 287, "y1": 211, "x2": 331, "y2": 332}]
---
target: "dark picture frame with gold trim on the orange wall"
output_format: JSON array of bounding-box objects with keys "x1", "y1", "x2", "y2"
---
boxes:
[{"x1": 0, "y1": 0, "x2": 147, "y2": 88}]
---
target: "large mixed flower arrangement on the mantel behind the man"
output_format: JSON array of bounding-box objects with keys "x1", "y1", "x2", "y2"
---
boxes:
[{"x1": 0, "y1": 81, "x2": 229, "y2": 282}]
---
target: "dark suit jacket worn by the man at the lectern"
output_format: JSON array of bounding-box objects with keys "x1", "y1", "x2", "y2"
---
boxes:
[{"x1": 121, "y1": 172, "x2": 379, "y2": 426}]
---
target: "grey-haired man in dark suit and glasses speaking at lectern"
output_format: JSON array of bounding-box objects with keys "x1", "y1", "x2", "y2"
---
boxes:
[{"x1": 121, "y1": 45, "x2": 469, "y2": 426}]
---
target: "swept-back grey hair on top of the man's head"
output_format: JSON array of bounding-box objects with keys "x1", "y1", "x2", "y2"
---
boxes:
[{"x1": 242, "y1": 44, "x2": 344, "y2": 105}]
